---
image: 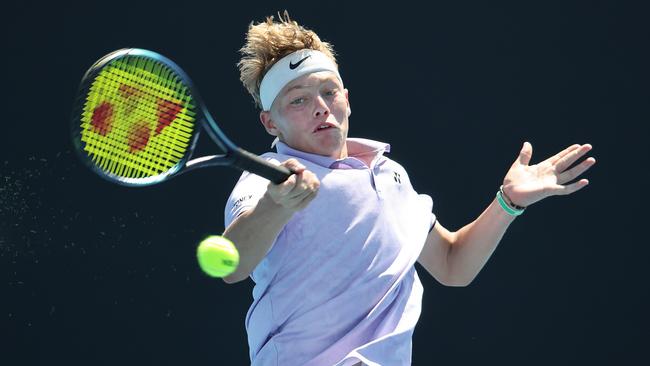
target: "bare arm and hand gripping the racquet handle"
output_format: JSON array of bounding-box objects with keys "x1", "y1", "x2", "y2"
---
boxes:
[{"x1": 223, "y1": 159, "x2": 320, "y2": 284}]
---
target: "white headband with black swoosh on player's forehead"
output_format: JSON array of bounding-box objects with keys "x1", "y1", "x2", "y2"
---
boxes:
[{"x1": 260, "y1": 49, "x2": 343, "y2": 111}]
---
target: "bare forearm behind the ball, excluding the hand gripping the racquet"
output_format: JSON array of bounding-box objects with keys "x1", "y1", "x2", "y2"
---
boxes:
[{"x1": 223, "y1": 195, "x2": 294, "y2": 283}]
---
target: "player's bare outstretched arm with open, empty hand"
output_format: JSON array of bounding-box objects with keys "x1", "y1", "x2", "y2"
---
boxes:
[{"x1": 418, "y1": 143, "x2": 596, "y2": 286}]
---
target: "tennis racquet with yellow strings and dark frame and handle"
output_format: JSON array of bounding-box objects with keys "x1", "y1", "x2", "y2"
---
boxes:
[{"x1": 71, "y1": 48, "x2": 292, "y2": 186}]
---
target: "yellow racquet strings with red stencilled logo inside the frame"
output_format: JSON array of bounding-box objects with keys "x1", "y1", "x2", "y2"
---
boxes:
[{"x1": 79, "y1": 55, "x2": 196, "y2": 183}]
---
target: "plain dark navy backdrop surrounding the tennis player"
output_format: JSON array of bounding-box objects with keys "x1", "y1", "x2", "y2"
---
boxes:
[{"x1": 0, "y1": 1, "x2": 650, "y2": 365}]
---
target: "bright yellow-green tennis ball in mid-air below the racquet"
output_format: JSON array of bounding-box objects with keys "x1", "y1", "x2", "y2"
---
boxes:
[{"x1": 196, "y1": 235, "x2": 239, "y2": 277}]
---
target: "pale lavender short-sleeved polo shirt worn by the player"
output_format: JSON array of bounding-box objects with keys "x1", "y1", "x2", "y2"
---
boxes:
[{"x1": 225, "y1": 138, "x2": 435, "y2": 366}]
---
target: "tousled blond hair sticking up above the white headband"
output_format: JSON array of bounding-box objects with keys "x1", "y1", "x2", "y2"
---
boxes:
[{"x1": 237, "y1": 10, "x2": 338, "y2": 109}]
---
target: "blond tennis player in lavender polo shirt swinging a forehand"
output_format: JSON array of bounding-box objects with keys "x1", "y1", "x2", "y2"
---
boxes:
[{"x1": 224, "y1": 12, "x2": 595, "y2": 366}]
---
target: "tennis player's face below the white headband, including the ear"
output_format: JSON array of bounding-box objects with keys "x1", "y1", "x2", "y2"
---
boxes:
[{"x1": 260, "y1": 71, "x2": 350, "y2": 159}]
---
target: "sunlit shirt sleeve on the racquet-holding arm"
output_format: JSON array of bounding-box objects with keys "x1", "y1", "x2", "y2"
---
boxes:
[{"x1": 224, "y1": 155, "x2": 279, "y2": 228}]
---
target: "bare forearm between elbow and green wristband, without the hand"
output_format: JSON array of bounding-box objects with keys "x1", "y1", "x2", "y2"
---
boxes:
[{"x1": 447, "y1": 199, "x2": 514, "y2": 285}]
